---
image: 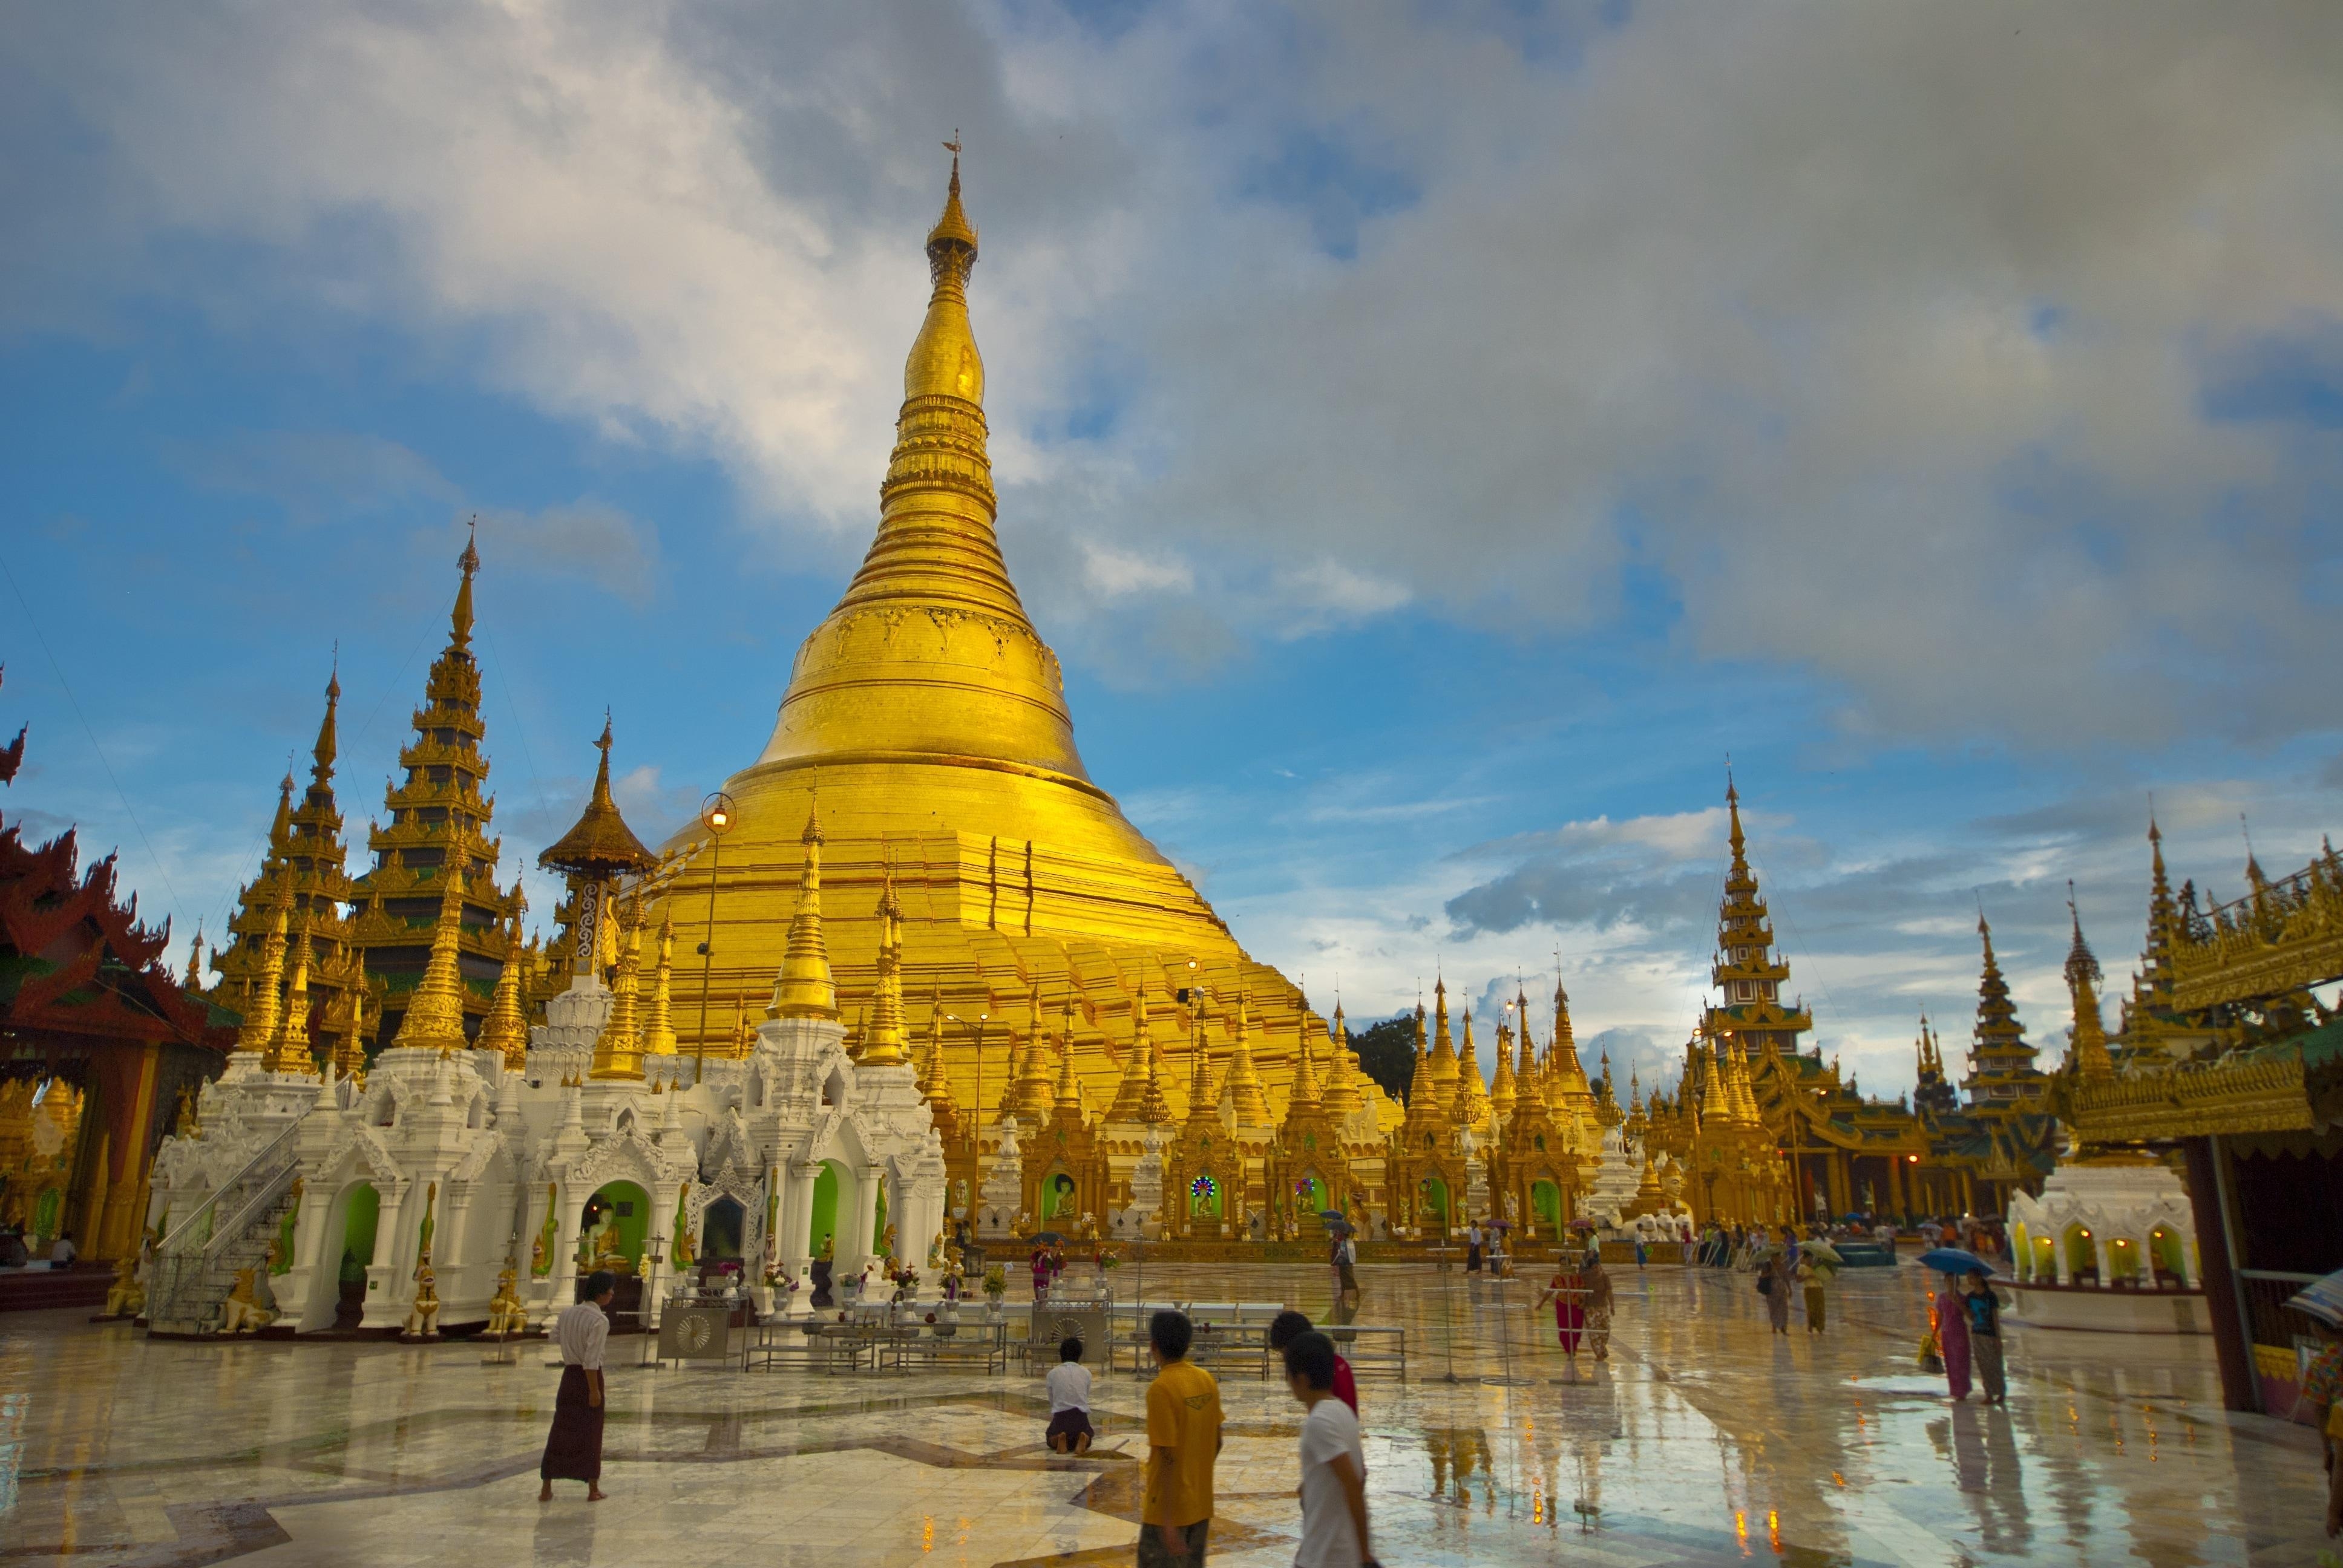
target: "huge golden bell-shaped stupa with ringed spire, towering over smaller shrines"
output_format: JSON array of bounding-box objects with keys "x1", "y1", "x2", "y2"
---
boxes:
[{"x1": 666, "y1": 155, "x2": 1377, "y2": 1128}]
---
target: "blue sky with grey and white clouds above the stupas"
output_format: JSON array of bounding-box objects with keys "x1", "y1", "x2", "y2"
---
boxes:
[{"x1": 0, "y1": 0, "x2": 2343, "y2": 1092}]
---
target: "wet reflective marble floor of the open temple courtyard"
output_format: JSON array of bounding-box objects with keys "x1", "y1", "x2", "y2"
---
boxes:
[{"x1": 0, "y1": 1266, "x2": 2324, "y2": 1568}]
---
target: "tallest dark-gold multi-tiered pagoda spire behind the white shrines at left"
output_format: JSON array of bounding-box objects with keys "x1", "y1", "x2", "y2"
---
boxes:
[{"x1": 352, "y1": 529, "x2": 520, "y2": 1043}]
